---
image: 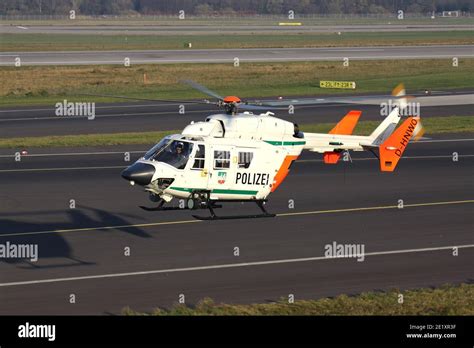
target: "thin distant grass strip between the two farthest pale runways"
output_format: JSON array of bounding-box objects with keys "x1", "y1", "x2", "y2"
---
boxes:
[{"x1": 0, "y1": 28, "x2": 474, "y2": 52}]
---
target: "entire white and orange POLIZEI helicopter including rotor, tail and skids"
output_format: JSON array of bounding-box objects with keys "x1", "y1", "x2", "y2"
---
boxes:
[{"x1": 90, "y1": 81, "x2": 421, "y2": 220}]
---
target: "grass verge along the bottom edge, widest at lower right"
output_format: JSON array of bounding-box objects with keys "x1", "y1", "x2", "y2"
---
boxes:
[{"x1": 122, "y1": 284, "x2": 474, "y2": 315}]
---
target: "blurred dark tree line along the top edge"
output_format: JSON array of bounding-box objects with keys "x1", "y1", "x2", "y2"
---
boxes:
[{"x1": 0, "y1": 0, "x2": 474, "y2": 15}]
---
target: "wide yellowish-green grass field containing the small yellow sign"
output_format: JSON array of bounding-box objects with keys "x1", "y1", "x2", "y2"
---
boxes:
[{"x1": 0, "y1": 59, "x2": 474, "y2": 107}]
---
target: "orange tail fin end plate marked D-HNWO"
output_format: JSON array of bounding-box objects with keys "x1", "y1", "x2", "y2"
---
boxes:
[{"x1": 379, "y1": 117, "x2": 420, "y2": 172}]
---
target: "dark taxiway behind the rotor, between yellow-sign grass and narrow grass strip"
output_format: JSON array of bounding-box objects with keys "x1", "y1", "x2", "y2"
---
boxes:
[{"x1": 0, "y1": 97, "x2": 474, "y2": 138}]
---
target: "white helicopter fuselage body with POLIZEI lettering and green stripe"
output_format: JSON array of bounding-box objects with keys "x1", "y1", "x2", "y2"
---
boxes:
[{"x1": 137, "y1": 113, "x2": 306, "y2": 201}]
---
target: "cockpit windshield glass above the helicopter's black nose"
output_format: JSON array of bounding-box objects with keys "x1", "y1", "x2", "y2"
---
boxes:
[{"x1": 143, "y1": 137, "x2": 193, "y2": 169}]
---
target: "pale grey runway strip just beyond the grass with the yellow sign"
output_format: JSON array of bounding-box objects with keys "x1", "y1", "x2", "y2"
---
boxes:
[{"x1": 0, "y1": 45, "x2": 474, "y2": 66}]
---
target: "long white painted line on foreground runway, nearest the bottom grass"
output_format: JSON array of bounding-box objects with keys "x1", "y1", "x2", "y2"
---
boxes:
[{"x1": 0, "y1": 244, "x2": 474, "y2": 287}]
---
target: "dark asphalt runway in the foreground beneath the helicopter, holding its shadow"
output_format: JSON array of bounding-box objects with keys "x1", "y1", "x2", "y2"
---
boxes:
[{"x1": 0, "y1": 134, "x2": 474, "y2": 314}]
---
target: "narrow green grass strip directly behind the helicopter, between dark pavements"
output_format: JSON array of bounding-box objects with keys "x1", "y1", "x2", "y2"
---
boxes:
[{"x1": 0, "y1": 116, "x2": 474, "y2": 149}]
